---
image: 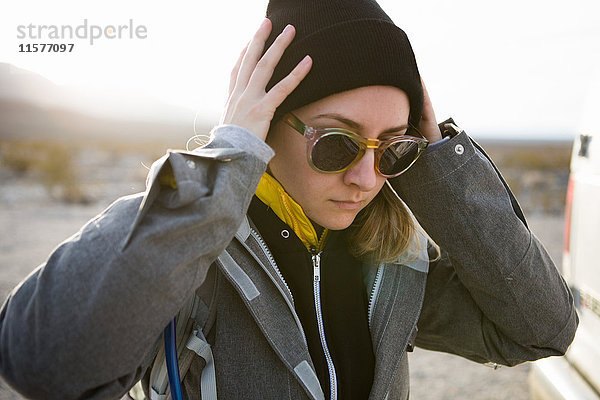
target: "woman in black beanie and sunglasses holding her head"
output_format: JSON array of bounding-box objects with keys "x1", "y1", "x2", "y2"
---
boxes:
[{"x1": 0, "y1": 0, "x2": 577, "y2": 399}]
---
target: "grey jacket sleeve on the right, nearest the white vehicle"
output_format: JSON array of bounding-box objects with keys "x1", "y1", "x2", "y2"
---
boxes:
[{"x1": 392, "y1": 132, "x2": 578, "y2": 365}]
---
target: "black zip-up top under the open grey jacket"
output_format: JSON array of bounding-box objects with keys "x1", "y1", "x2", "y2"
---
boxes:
[{"x1": 249, "y1": 196, "x2": 375, "y2": 400}]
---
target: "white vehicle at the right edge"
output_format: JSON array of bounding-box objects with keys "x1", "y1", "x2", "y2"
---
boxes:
[{"x1": 529, "y1": 79, "x2": 600, "y2": 400}]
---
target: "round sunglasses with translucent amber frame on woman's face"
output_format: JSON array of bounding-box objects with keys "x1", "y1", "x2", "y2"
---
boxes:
[{"x1": 282, "y1": 113, "x2": 429, "y2": 178}]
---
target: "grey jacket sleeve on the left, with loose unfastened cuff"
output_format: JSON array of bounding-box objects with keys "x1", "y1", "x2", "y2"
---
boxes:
[{"x1": 0, "y1": 126, "x2": 273, "y2": 399}]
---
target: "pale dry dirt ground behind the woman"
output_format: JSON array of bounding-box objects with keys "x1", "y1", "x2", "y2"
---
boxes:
[{"x1": 0, "y1": 149, "x2": 562, "y2": 400}]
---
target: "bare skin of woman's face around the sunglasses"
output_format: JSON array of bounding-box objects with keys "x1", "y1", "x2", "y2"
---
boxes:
[{"x1": 267, "y1": 86, "x2": 409, "y2": 230}]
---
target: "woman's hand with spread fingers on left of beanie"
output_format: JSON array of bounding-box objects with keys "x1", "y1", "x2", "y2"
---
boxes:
[{"x1": 220, "y1": 19, "x2": 312, "y2": 140}]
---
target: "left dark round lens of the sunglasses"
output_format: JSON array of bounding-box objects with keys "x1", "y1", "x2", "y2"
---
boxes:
[{"x1": 311, "y1": 133, "x2": 360, "y2": 172}]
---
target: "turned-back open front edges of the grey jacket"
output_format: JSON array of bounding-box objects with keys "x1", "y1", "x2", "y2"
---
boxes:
[{"x1": 224, "y1": 219, "x2": 427, "y2": 400}]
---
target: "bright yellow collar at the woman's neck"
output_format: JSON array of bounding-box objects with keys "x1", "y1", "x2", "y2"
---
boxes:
[{"x1": 256, "y1": 173, "x2": 329, "y2": 251}]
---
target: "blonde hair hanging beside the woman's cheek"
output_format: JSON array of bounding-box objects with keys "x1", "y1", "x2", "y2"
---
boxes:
[{"x1": 348, "y1": 184, "x2": 439, "y2": 262}]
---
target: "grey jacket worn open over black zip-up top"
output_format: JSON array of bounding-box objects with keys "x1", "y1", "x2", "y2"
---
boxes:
[{"x1": 0, "y1": 126, "x2": 578, "y2": 399}]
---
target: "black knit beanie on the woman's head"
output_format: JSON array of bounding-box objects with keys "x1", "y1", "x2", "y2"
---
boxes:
[{"x1": 265, "y1": 0, "x2": 423, "y2": 126}]
